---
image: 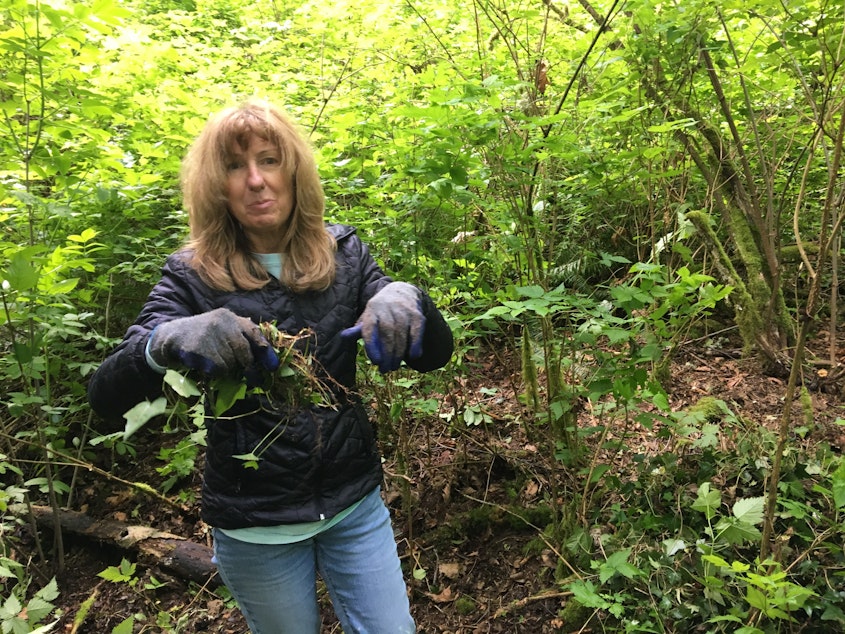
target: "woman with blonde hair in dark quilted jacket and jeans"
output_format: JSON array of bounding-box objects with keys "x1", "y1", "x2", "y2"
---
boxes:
[{"x1": 88, "y1": 100, "x2": 453, "y2": 634}]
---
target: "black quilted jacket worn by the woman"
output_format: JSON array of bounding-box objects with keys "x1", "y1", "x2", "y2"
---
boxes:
[{"x1": 88, "y1": 225, "x2": 453, "y2": 528}]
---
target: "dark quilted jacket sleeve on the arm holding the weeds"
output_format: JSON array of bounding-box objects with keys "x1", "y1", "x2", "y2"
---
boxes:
[{"x1": 88, "y1": 257, "x2": 202, "y2": 426}]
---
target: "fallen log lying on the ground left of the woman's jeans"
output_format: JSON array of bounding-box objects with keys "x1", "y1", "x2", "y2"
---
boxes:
[{"x1": 32, "y1": 506, "x2": 222, "y2": 587}]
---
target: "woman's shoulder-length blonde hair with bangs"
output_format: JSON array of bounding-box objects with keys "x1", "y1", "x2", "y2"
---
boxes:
[{"x1": 182, "y1": 99, "x2": 336, "y2": 292}]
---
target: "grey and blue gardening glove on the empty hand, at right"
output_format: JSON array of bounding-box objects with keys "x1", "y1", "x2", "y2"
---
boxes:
[{"x1": 340, "y1": 282, "x2": 425, "y2": 373}]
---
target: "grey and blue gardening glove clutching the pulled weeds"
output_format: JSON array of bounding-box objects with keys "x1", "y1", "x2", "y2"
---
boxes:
[{"x1": 147, "y1": 308, "x2": 279, "y2": 376}]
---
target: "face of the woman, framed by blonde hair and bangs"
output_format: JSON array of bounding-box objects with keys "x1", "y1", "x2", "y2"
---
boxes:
[{"x1": 226, "y1": 135, "x2": 293, "y2": 253}]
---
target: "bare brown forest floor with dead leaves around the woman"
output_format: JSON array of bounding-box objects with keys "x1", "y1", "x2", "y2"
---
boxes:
[{"x1": 31, "y1": 337, "x2": 845, "y2": 634}]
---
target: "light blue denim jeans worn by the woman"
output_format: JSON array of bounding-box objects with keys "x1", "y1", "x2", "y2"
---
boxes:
[{"x1": 214, "y1": 488, "x2": 416, "y2": 634}]
